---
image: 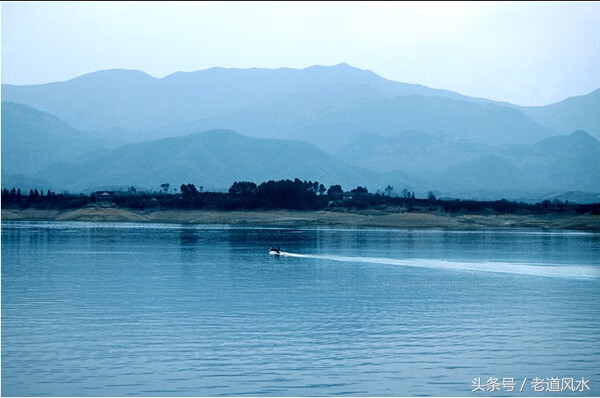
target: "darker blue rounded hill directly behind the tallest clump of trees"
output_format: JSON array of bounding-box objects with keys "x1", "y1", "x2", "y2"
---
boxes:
[{"x1": 36, "y1": 130, "x2": 398, "y2": 190}]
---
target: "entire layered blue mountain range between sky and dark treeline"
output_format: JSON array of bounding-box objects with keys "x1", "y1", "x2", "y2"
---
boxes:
[{"x1": 2, "y1": 64, "x2": 600, "y2": 199}]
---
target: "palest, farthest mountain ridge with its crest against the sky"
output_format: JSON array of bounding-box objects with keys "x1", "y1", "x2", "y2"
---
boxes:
[{"x1": 2, "y1": 64, "x2": 482, "y2": 131}]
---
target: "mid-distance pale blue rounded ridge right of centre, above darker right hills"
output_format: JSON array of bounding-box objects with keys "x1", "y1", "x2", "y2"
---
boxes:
[{"x1": 289, "y1": 96, "x2": 554, "y2": 150}]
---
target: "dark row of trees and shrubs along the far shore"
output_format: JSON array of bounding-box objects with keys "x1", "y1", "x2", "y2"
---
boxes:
[{"x1": 2, "y1": 178, "x2": 600, "y2": 214}]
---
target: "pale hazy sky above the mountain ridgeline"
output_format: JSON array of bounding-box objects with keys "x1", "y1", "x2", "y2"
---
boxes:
[{"x1": 2, "y1": 1, "x2": 600, "y2": 105}]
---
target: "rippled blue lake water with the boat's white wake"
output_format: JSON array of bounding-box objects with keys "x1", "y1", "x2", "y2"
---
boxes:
[{"x1": 2, "y1": 222, "x2": 600, "y2": 396}]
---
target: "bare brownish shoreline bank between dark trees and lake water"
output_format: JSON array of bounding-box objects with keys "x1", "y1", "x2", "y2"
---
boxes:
[{"x1": 1, "y1": 206, "x2": 600, "y2": 232}]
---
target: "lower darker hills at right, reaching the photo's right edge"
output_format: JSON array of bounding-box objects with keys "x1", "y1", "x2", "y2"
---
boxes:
[{"x1": 336, "y1": 131, "x2": 600, "y2": 198}]
